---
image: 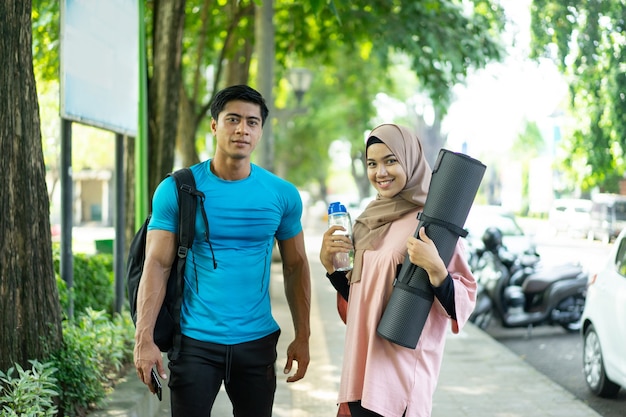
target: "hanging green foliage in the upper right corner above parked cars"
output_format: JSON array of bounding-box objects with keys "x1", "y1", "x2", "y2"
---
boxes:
[{"x1": 531, "y1": 0, "x2": 626, "y2": 192}]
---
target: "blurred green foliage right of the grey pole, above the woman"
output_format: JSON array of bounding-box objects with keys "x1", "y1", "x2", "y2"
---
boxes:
[{"x1": 275, "y1": 0, "x2": 504, "y2": 197}]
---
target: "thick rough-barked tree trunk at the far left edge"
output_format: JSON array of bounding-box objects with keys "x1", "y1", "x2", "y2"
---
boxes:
[{"x1": 0, "y1": 0, "x2": 63, "y2": 371}]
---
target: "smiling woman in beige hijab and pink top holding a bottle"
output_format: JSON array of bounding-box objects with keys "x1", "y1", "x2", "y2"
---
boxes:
[{"x1": 320, "y1": 124, "x2": 476, "y2": 417}]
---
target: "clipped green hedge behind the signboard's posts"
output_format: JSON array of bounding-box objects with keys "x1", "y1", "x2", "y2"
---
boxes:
[{"x1": 53, "y1": 244, "x2": 115, "y2": 314}]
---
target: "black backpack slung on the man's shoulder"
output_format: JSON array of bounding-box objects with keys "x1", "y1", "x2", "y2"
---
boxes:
[{"x1": 126, "y1": 168, "x2": 208, "y2": 354}]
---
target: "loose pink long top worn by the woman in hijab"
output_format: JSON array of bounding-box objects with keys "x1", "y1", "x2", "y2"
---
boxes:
[{"x1": 338, "y1": 212, "x2": 476, "y2": 417}]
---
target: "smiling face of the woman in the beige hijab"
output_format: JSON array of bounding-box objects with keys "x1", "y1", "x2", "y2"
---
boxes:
[{"x1": 366, "y1": 143, "x2": 407, "y2": 198}]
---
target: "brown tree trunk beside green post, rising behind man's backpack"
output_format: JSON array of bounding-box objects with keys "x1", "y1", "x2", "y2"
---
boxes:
[{"x1": 148, "y1": 0, "x2": 185, "y2": 196}]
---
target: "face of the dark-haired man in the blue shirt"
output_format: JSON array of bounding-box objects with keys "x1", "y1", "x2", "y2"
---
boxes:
[{"x1": 211, "y1": 101, "x2": 263, "y2": 159}]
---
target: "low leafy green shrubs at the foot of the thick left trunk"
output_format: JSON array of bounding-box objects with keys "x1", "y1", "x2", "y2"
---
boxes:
[{"x1": 0, "y1": 308, "x2": 134, "y2": 417}]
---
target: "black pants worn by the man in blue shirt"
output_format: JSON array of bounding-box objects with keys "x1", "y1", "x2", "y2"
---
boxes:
[{"x1": 168, "y1": 330, "x2": 280, "y2": 417}]
